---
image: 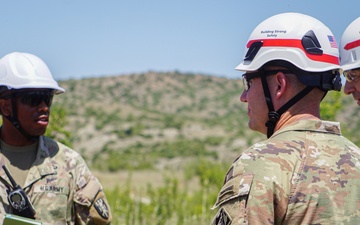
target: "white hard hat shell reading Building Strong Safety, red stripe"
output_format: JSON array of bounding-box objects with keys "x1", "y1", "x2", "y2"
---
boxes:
[{"x1": 235, "y1": 13, "x2": 340, "y2": 72}]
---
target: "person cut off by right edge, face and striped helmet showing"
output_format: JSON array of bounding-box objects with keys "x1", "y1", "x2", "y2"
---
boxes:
[{"x1": 340, "y1": 17, "x2": 360, "y2": 106}]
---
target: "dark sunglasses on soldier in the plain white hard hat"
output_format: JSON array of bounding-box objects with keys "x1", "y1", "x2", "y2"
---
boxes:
[{"x1": 12, "y1": 91, "x2": 54, "y2": 107}]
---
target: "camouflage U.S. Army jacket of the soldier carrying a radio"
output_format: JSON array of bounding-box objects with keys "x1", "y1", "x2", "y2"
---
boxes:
[{"x1": 0, "y1": 136, "x2": 111, "y2": 225}]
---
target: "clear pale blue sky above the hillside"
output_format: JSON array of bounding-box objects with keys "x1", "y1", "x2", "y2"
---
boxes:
[{"x1": 0, "y1": 0, "x2": 360, "y2": 80}]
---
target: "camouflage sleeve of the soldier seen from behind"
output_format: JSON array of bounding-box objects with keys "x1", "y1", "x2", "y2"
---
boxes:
[{"x1": 212, "y1": 149, "x2": 292, "y2": 225}]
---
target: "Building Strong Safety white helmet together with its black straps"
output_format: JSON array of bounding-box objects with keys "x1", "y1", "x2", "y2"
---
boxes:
[{"x1": 236, "y1": 13, "x2": 341, "y2": 137}]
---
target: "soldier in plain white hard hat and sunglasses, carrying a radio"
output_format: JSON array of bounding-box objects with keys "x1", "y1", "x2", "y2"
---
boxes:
[{"x1": 0, "y1": 52, "x2": 112, "y2": 225}]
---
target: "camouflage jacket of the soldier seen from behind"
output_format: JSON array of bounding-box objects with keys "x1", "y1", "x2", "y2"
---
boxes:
[{"x1": 212, "y1": 120, "x2": 360, "y2": 225}]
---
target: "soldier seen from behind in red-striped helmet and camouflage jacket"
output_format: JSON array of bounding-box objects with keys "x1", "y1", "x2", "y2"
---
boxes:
[{"x1": 212, "y1": 13, "x2": 360, "y2": 225}]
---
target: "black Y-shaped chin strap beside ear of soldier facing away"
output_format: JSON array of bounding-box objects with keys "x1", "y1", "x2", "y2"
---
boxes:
[{"x1": 261, "y1": 74, "x2": 314, "y2": 138}]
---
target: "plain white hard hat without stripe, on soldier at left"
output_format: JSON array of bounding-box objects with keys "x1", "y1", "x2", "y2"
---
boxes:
[{"x1": 0, "y1": 52, "x2": 65, "y2": 94}]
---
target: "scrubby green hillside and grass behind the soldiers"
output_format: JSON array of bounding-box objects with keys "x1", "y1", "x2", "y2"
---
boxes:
[{"x1": 48, "y1": 71, "x2": 360, "y2": 224}]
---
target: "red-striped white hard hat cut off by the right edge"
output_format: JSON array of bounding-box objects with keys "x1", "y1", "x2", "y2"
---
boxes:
[{"x1": 340, "y1": 17, "x2": 360, "y2": 71}]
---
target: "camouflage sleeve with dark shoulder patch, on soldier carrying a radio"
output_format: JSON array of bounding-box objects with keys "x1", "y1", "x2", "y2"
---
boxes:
[{"x1": 74, "y1": 176, "x2": 112, "y2": 225}]
